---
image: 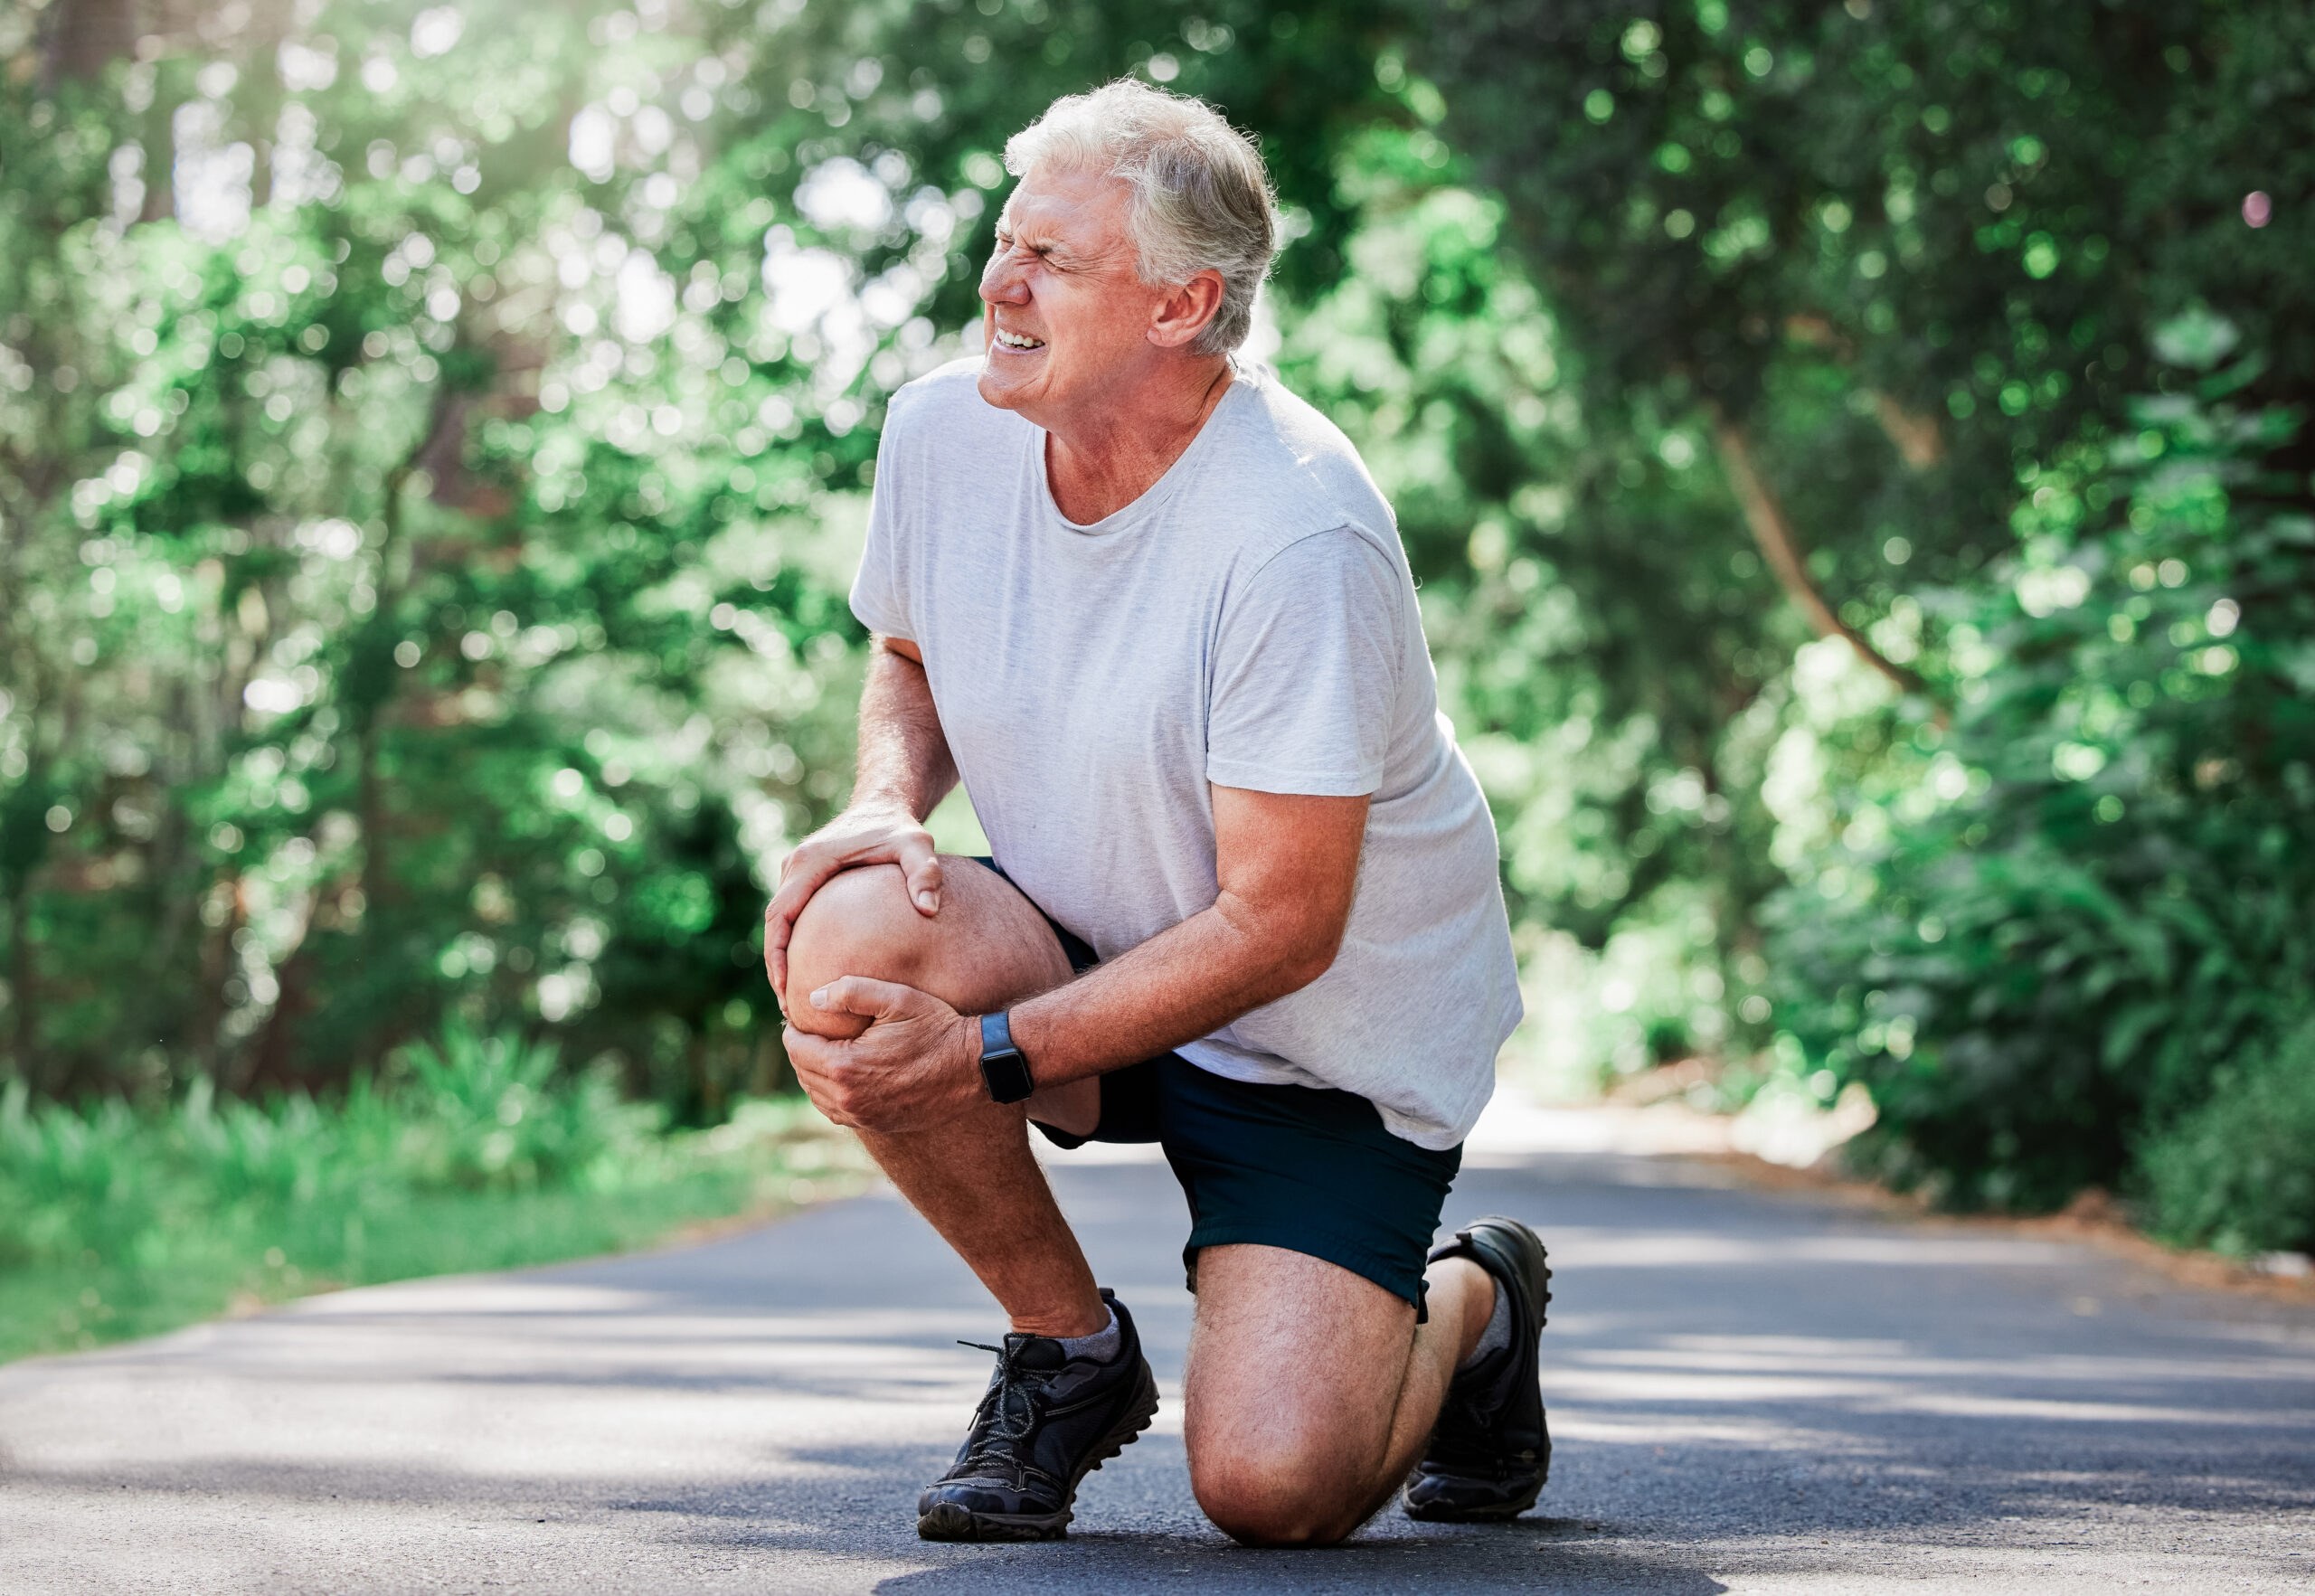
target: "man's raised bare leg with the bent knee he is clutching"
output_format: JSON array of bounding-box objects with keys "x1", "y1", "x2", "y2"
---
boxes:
[{"x1": 782, "y1": 855, "x2": 1109, "y2": 1336}]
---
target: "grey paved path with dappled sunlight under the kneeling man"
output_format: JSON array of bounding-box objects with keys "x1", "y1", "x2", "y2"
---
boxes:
[{"x1": 0, "y1": 1116, "x2": 2315, "y2": 1596}]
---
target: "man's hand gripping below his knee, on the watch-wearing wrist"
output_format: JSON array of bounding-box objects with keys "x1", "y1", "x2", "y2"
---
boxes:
[{"x1": 780, "y1": 975, "x2": 993, "y2": 1135}]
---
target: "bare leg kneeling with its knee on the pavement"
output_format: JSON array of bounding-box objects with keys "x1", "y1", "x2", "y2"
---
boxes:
[{"x1": 1183, "y1": 1246, "x2": 1496, "y2": 1545}]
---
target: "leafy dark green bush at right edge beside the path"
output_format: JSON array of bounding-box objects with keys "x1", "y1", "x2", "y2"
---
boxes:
[{"x1": 1778, "y1": 333, "x2": 2315, "y2": 1209}]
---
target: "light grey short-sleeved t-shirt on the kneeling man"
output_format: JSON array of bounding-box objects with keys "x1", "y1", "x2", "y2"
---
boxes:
[{"x1": 852, "y1": 362, "x2": 1521, "y2": 1149}]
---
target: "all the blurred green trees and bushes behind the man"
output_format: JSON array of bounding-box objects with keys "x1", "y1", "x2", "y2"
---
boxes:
[{"x1": 0, "y1": 0, "x2": 2315, "y2": 1242}]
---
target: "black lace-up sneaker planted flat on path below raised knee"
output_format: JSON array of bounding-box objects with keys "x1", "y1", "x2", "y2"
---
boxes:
[{"x1": 917, "y1": 1290, "x2": 1158, "y2": 1541}]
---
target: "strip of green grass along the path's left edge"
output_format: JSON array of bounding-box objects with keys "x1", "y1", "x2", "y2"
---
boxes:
[{"x1": 0, "y1": 1028, "x2": 865, "y2": 1360}]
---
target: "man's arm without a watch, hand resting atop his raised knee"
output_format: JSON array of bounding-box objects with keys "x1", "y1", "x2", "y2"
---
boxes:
[{"x1": 764, "y1": 637, "x2": 956, "y2": 1007}]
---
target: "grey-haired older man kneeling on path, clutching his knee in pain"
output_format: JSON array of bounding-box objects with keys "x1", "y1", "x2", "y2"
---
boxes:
[{"x1": 764, "y1": 83, "x2": 1549, "y2": 1545}]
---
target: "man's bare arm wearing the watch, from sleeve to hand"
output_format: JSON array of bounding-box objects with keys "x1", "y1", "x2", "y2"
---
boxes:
[{"x1": 787, "y1": 788, "x2": 1368, "y2": 1130}]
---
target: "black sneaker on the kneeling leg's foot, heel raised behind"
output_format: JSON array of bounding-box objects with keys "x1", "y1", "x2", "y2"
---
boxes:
[{"x1": 1401, "y1": 1214, "x2": 1551, "y2": 1525}]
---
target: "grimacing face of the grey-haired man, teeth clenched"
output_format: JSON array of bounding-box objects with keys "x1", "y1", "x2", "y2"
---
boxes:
[{"x1": 981, "y1": 166, "x2": 1169, "y2": 426}]
